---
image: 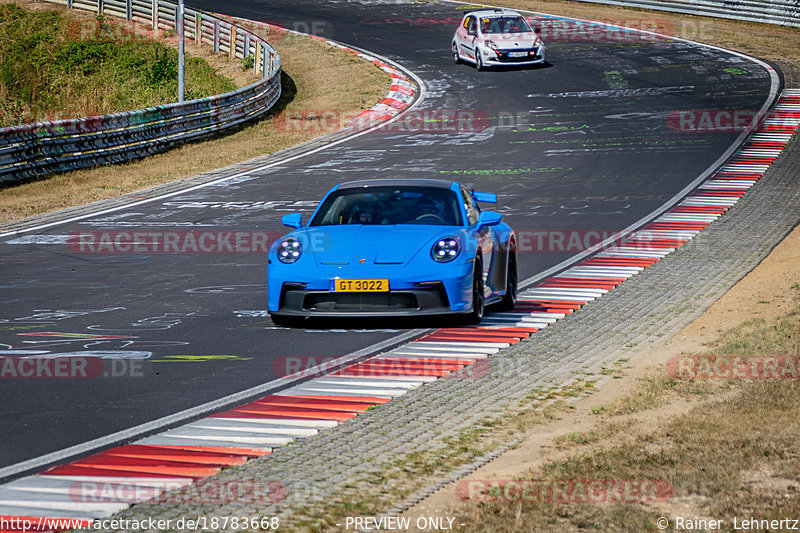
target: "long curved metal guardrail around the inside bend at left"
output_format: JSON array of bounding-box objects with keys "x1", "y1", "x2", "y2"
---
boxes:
[{"x1": 0, "y1": 0, "x2": 281, "y2": 181}]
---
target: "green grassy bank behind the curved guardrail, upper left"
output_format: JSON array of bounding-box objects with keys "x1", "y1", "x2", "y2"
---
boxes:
[{"x1": 0, "y1": 4, "x2": 236, "y2": 126}]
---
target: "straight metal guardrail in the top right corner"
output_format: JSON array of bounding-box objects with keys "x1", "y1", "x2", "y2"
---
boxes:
[{"x1": 573, "y1": 0, "x2": 800, "y2": 27}]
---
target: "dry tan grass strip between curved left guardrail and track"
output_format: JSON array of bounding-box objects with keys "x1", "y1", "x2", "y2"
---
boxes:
[{"x1": 0, "y1": 5, "x2": 389, "y2": 222}]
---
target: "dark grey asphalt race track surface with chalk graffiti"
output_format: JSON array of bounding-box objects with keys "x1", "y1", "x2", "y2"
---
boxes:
[{"x1": 0, "y1": 0, "x2": 770, "y2": 474}]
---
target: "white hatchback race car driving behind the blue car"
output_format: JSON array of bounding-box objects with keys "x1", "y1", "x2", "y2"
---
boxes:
[{"x1": 453, "y1": 9, "x2": 544, "y2": 70}]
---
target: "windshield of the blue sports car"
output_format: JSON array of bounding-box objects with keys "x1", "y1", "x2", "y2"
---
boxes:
[{"x1": 309, "y1": 186, "x2": 462, "y2": 226}]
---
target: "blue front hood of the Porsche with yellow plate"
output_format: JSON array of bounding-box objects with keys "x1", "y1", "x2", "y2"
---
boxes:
[{"x1": 301, "y1": 225, "x2": 460, "y2": 265}]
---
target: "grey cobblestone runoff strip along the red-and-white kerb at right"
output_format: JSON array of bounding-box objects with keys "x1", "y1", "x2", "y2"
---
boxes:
[{"x1": 95, "y1": 130, "x2": 800, "y2": 530}]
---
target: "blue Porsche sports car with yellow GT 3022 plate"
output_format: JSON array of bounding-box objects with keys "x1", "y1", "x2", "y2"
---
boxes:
[{"x1": 267, "y1": 179, "x2": 517, "y2": 325}]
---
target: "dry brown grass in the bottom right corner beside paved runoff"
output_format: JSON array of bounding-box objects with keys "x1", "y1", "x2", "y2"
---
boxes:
[{"x1": 459, "y1": 294, "x2": 800, "y2": 532}]
